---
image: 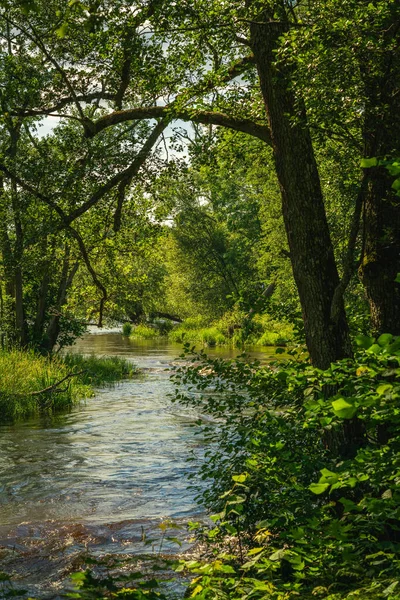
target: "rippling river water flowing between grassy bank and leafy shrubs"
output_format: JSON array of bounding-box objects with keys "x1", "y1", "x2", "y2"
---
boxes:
[{"x1": 0, "y1": 332, "x2": 276, "y2": 598}]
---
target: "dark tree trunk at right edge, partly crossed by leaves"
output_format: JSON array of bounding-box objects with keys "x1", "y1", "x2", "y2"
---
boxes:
[{"x1": 360, "y1": 30, "x2": 400, "y2": 335}]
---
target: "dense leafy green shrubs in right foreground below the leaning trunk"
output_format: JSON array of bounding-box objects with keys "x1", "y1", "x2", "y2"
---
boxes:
[{"x1": 171, "y1": 334, "x2": 400, "y2": 600}]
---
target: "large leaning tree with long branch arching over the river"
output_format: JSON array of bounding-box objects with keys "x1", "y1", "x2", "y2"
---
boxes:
[{"x1": 2, "y1": 0, "x2": 397, "y2": 367}]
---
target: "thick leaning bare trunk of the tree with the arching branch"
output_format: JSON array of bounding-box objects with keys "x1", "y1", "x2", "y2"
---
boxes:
[{"x1": 250, "y1": 13, "x2": 351, "y2": 368}]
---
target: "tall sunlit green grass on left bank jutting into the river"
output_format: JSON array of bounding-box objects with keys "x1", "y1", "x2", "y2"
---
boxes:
[{"x1": 0, "y1": 350, "x2": 137, "y2": 422}]
